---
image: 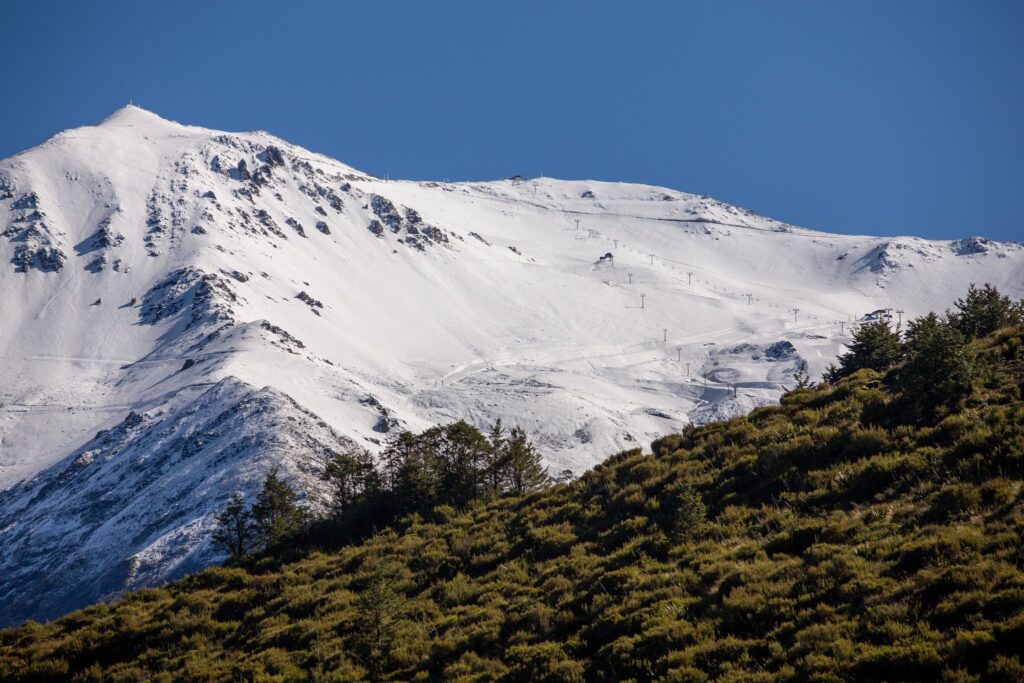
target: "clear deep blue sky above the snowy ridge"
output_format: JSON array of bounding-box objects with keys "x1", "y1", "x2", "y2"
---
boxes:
[{"x1": 0, "y1": 0, "x2": 1024, "y2": 240}]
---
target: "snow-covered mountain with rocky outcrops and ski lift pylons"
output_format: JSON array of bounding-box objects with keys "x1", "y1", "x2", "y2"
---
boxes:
[{"x1": 0, "y1": 106, "x2": 1024, "y2": 623}]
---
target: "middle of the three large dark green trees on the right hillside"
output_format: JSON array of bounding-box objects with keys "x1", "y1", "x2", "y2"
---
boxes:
[{"x1": 897, "y1": 313, "x2": 975, "y2": 421}]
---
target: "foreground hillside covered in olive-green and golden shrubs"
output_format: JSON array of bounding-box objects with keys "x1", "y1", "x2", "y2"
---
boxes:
[{"x1": 0, "y1": 331, "x2": 1024, "y2": 681}]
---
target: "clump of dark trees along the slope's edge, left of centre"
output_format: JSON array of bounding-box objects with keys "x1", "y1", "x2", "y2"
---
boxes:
[{"x1": 212, "y1": 420, "x2": 566, "y2": 560}]
